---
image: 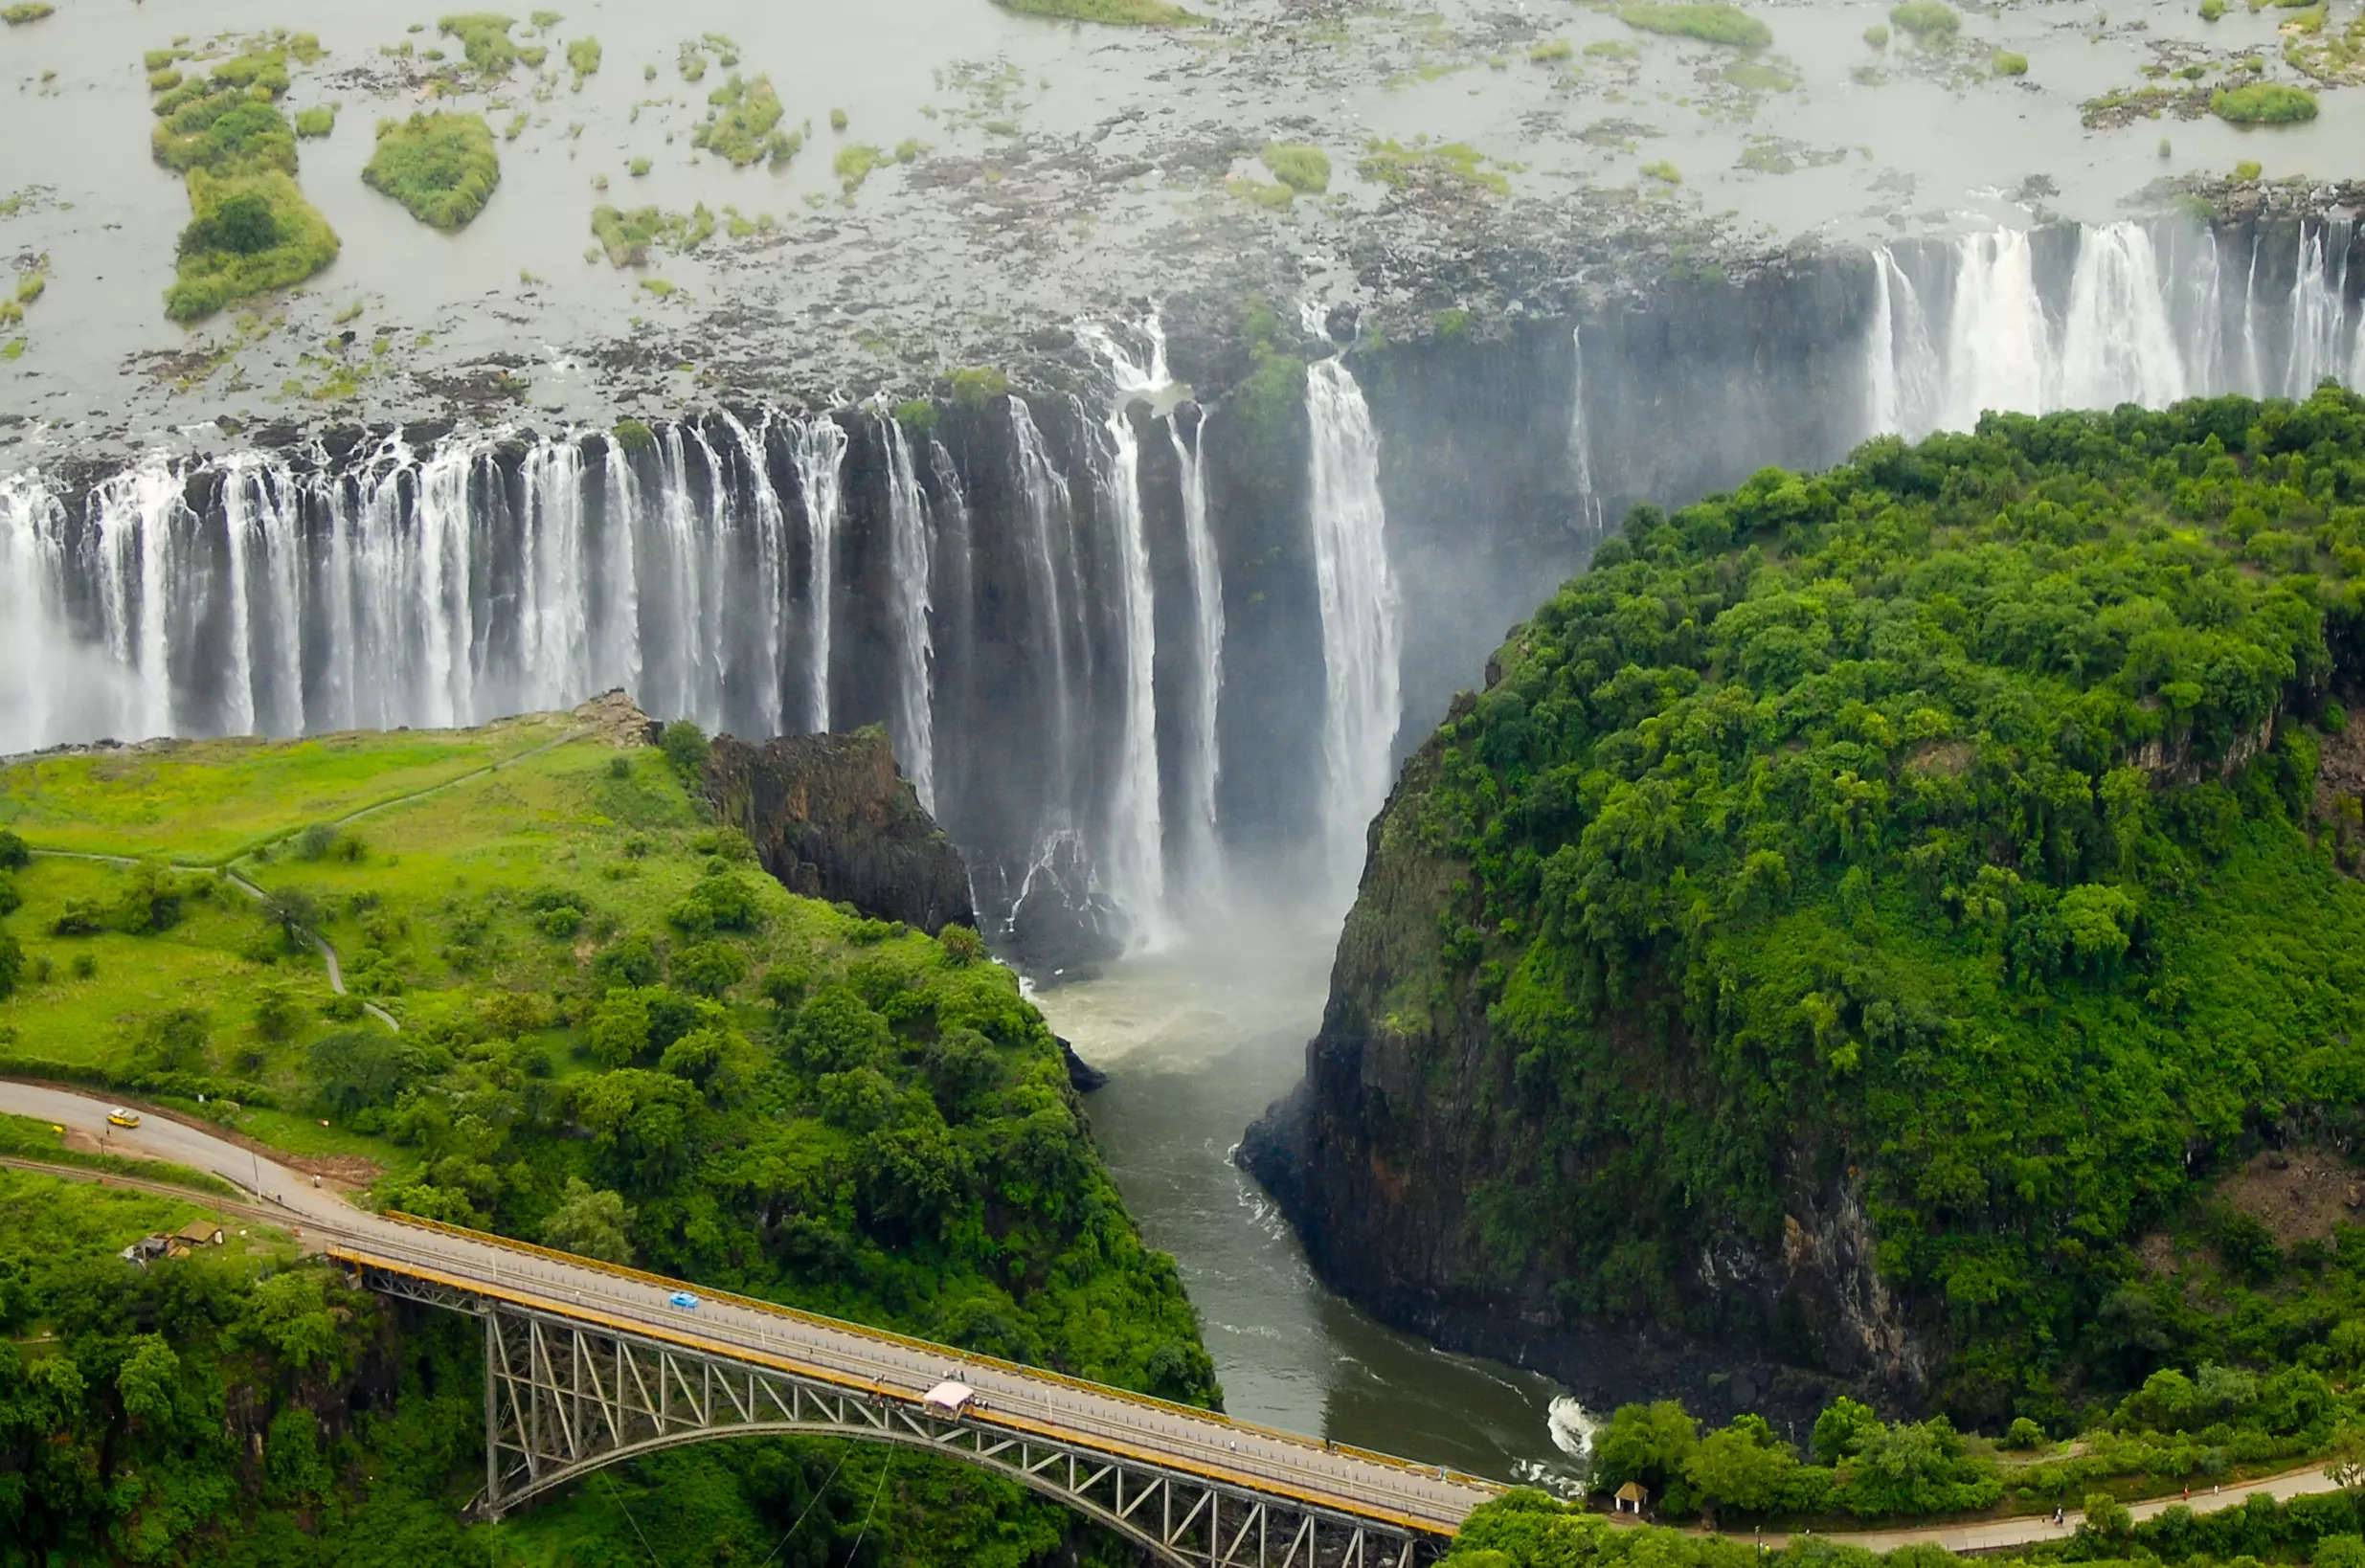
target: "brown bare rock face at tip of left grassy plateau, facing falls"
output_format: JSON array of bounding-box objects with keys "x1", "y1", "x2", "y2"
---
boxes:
[{"x1": 705, "y1": 726, "x2": 977, "y2": 934}]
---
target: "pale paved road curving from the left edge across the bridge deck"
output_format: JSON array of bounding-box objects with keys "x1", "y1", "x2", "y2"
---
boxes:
[{"x1": 0, "y1": 1084, "x2": 1501, "y2": 1533}]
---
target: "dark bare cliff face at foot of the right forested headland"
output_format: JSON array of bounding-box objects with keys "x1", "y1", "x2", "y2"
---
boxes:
[{"x1": 1237, "y1": 719, "x2": 1873, "y2": 1422}]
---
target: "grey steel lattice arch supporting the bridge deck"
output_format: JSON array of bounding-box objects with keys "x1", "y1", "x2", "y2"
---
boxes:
[{"x1": 357, "y1": 1261, "x2": 1450, "y2": 1568}]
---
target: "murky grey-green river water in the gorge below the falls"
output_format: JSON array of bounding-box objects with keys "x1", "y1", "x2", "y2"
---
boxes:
[{"x1": 1033, "y1": 910, "x2": 1580, "y2": 1488}]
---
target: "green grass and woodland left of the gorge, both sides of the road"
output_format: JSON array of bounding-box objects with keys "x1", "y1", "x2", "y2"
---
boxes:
[{"x1": 0, "y1": 714, "x2": 1218, "y2": 1568}]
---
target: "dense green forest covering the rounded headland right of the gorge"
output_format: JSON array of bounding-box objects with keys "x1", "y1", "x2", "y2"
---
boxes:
[{"x1": 1381, "y1": 388, "x2": 2365, "y2": 1436}]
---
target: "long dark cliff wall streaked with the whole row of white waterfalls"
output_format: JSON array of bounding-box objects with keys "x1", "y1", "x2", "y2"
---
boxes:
[{"x1": 0, "y1": 220, "x2": 2365, "y2": 972}]
